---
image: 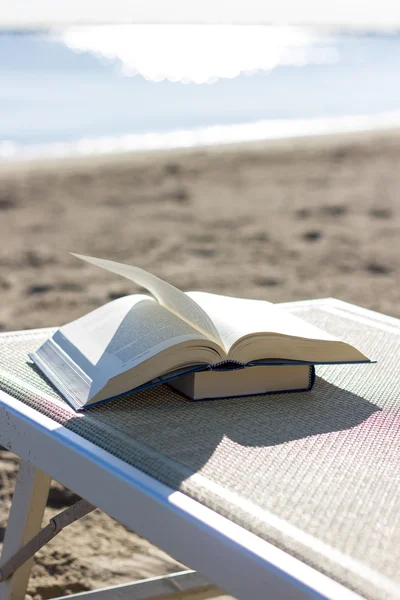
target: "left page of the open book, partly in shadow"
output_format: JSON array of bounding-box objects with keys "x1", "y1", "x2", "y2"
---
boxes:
[{"x1": 53, "y1": 294, "x2": 212, "y2": 380}]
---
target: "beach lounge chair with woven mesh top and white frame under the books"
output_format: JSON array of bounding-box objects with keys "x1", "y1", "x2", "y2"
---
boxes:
[{"x1": 0, "y1": 299, "x2": 400, "y2": 600}]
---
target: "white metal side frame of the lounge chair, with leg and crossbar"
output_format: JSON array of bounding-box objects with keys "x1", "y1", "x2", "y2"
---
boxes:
[{"x1": 0, "y1": 356, "x2": 360, "y2": 600}]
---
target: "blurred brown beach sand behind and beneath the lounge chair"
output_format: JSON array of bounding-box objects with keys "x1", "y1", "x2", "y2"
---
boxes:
[{"x1": 0, "y1": 132, "x2": 400, "y2": 600}]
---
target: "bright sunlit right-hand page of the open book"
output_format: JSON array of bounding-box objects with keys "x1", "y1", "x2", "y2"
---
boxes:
[{"x1": 186, "y1": 292, "x2": 336, "y2": 353}]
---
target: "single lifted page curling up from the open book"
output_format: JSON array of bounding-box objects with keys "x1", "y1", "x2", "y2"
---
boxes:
[{"x1": 73, "y1": 254, "x2": 221, "y2": 345}]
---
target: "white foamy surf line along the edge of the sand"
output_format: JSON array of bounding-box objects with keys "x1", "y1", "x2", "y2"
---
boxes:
[{"x1": 0, "y1": 111, "x2": 400, "y2": 162}]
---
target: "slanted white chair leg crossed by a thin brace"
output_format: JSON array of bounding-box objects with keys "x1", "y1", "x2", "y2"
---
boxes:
[{"x1": 0, "y1": 460, "x2": 51, "y2": 600}]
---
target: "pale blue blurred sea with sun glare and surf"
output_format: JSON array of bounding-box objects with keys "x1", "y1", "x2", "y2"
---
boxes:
[{"x1": 0, "y1": 28, "x2": 400, "y2": 161}]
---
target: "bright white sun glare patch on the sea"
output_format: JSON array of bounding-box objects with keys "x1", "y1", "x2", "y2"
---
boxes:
[{"x1": 54, "y1": 25, "x2": 338, "y2": 83}]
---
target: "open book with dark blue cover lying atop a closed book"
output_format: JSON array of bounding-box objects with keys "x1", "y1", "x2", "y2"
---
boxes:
[{"x1": 30, "y1": 255, "x2": 369, "y2": 410}]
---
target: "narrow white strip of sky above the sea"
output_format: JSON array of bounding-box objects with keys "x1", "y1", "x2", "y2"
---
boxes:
[{"x1": 0, "y1": 0, "x2": 400, "y2": 31}]
